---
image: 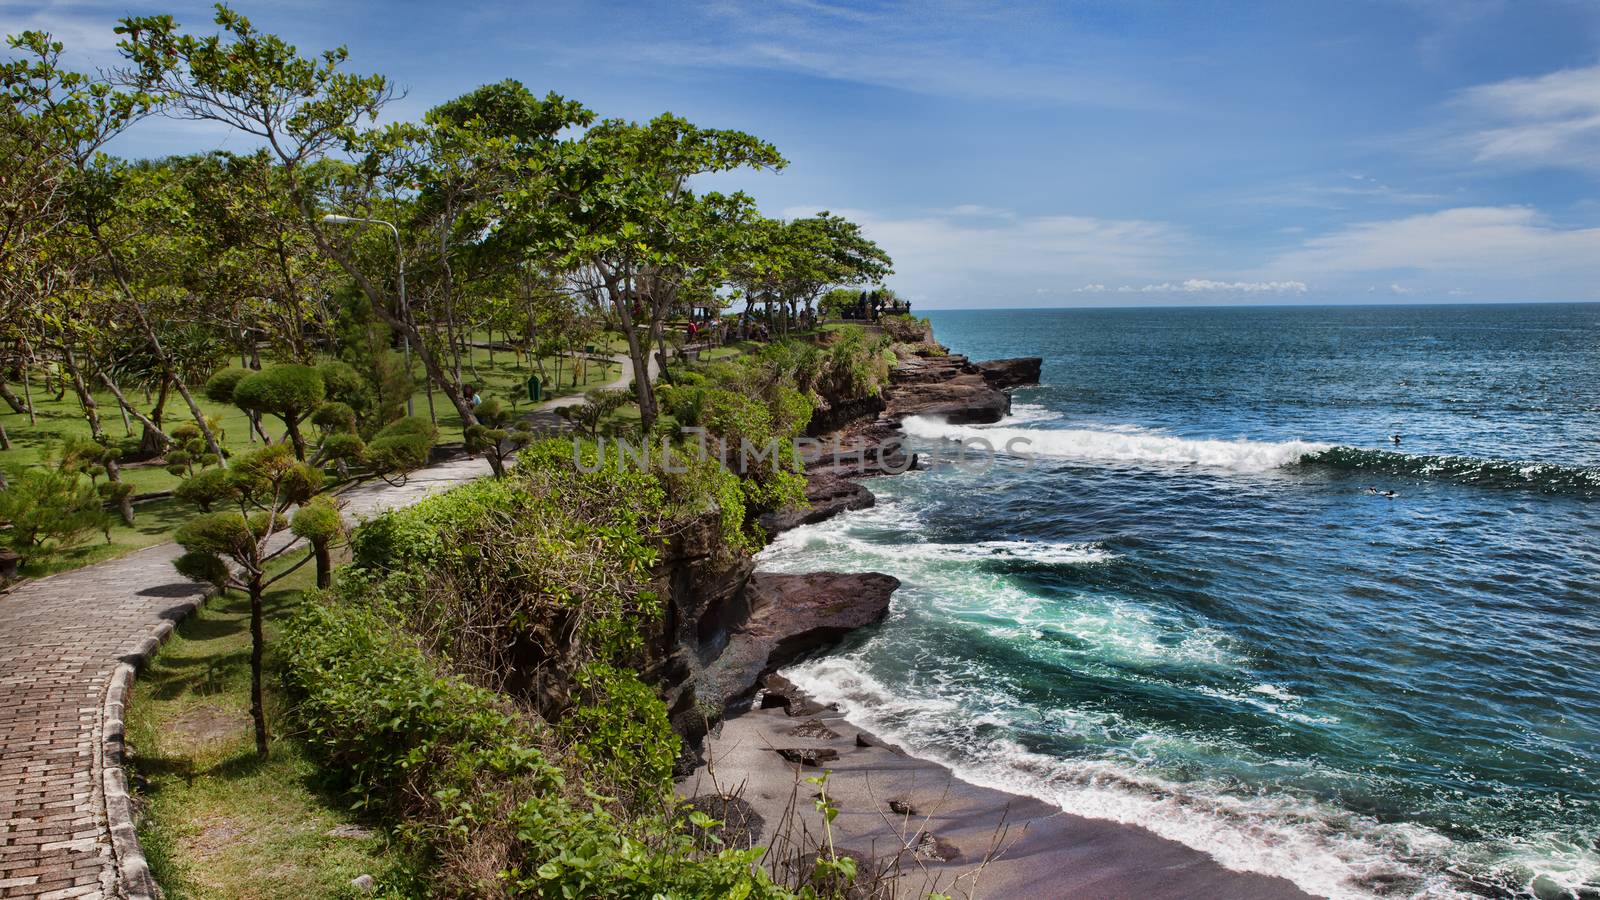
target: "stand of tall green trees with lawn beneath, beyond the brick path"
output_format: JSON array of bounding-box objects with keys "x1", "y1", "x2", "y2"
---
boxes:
[{"x1": 0, "y1": 6, "x2": 890, "y2": 575}]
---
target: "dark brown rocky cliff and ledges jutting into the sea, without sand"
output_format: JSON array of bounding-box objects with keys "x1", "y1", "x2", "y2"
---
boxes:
[{"x1": 646, "y1": 335, "x2": 1040, "y2": 773}]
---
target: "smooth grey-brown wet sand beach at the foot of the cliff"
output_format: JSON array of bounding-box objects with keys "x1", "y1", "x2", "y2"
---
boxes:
[{"x1": 678, "y1": 708, "x2": 1309, "y2": 900}]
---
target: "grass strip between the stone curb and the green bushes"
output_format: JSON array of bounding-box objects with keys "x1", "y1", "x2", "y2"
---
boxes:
[{"x1": 128, "y1": 565, "x2": 398, "y2": 900}]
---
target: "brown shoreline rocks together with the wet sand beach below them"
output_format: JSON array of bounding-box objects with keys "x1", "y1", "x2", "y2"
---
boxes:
[{"x1": 669, "y1": 333, "x2": 1307, "y2": 900}]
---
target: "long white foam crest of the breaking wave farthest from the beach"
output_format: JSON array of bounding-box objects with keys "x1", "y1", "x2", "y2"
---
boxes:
[{"x1": 901, "y1": 416, "x2": 1330, "y2": 472}]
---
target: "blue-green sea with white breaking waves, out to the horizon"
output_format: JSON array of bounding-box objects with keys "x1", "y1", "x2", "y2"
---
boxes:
[{"x1": 762, "y1": 306, "x2": 1600, "y2": 897}]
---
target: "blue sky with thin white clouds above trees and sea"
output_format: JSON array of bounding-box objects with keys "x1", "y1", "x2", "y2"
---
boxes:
[{"x1": 0, "y1": 0, "x2": 1600, "y2": 307}]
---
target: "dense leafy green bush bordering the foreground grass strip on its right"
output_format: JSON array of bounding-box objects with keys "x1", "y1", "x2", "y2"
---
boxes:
[{"x1": 282, "y1": 581, "x2": 790, "y2": 900}]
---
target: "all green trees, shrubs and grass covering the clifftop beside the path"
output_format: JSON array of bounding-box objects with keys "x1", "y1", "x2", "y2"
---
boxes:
[{"x1": 0, "y1": 6, "x2": 940, "y2": 897}]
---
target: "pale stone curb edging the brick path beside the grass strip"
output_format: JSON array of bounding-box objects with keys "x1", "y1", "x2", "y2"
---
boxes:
[{"x1": 99, "y1": 591, "x2": 211, "y2": 900}]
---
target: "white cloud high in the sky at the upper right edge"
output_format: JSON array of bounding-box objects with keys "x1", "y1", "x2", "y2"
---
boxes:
[{"x1": 1454, "y1": 66, "x2": 1600, "y2": 171}]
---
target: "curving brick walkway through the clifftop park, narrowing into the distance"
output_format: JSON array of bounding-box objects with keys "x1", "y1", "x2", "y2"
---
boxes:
[{"x1": 0, "y1": 458, "x2": 490, "y2": 900}]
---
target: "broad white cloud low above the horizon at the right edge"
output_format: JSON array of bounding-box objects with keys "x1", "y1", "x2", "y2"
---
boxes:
[{"x1": 1261, "y1": 207, "x2": 1600, "y2": 299}]
